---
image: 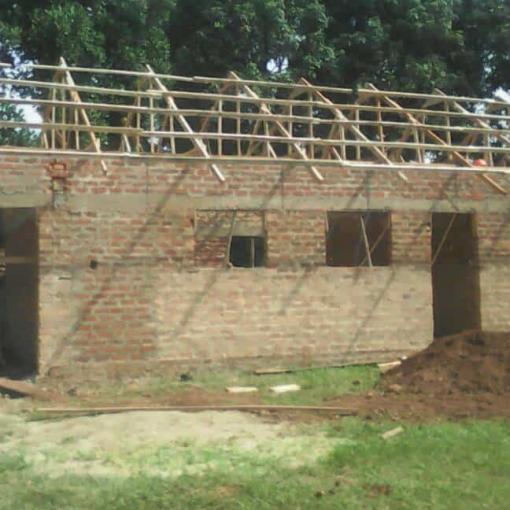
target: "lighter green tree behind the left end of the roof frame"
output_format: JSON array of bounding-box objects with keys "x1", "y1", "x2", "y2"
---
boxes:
[{"x1": 0, "y1": 0, "x2": 174, "y2": 71}]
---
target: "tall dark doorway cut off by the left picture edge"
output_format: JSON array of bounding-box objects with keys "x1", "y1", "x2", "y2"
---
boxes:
[{"x1": 0, "y1": 208, "x2": 38, "y2": 378}]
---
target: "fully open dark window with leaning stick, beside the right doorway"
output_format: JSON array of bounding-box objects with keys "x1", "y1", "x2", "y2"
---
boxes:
[{"x1": 326, "y1": 211, "x2": 391, "y2": 267}]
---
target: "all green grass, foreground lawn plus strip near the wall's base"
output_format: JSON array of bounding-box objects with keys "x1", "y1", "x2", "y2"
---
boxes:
[{"x1": 0, "y1": 367, "x2": 510, "y2": 510}]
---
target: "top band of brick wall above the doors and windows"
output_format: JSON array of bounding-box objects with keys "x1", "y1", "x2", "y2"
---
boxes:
[{"x1": 0, "y1": 156, "x2": 510, "y2": 212}]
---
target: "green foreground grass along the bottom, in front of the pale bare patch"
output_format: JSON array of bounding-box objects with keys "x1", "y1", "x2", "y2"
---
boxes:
[{"x1": 0, "y1": 418, "x2": 510, "y2": 510}]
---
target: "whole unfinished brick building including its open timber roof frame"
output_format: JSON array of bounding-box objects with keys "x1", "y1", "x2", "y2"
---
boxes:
[{"x1": 0, "y1": 63, "x2": 510, "y2": 375}]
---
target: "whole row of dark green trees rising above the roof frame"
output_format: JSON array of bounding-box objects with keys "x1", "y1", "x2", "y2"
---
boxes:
[{"x1": 0, "y1": 0, "x2": 510, "y2": 94}]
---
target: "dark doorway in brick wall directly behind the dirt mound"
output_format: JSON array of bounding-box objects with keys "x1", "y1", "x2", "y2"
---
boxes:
[{"x1": 431, "y1": 213, "x2": 481, "y2": 338}]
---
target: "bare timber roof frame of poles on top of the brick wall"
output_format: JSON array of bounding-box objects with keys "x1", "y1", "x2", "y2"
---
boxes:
[{"x1": 0, "y1": 58, "x2": 510, "y2": 193}]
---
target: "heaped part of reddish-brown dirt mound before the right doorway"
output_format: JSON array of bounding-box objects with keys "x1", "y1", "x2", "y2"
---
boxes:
[{"x1": 380, "y1": 331, "x2": 510, "y2": 395}]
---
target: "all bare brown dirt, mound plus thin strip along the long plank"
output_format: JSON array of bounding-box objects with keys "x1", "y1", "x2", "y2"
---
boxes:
[{"x1": 7, "y1": 331, "x2": 510, "y2": 421}]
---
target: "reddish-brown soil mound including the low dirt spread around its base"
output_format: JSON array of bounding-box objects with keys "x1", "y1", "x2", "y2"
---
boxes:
[{"x1": 328, "y1": 331, "x2": 510, "y2": 420}]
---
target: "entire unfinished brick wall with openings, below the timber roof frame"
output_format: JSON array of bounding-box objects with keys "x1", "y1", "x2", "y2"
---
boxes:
[{"x1": 0, "y1": 157, "x2": 510, "y2": 373}]
